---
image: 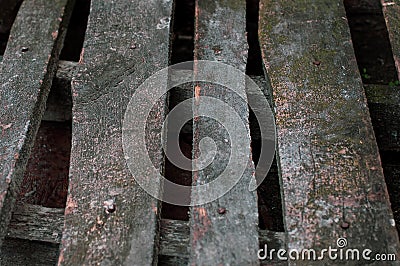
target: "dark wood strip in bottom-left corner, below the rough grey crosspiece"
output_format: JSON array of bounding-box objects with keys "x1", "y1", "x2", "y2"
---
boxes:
[{"x1": 0, "y1": 238, "x2": 59, "y2": 266}]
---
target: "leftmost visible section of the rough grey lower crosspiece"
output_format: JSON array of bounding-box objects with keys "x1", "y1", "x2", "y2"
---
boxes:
[{"x1": 7, "y1": 204, "x2": 64, "y2": 244}]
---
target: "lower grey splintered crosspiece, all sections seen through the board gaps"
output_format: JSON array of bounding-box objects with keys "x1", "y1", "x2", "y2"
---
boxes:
[{"x1": 7, "y1": 204, "x2": 285, "y2": 258}]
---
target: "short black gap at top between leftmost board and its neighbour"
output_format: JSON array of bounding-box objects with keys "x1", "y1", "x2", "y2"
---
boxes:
[{"x1": 60, "y1": 0, "x2": 90, "y2": 62}]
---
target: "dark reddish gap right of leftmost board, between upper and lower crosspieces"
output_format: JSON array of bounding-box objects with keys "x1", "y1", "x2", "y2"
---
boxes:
[{"x1": 18, "y1": 74, "x2": 72, "y2": 208}]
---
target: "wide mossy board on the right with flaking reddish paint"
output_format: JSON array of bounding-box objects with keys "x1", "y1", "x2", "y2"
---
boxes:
[{"x1": 259, "y1": 0, "x2": 400, "y2": 263}]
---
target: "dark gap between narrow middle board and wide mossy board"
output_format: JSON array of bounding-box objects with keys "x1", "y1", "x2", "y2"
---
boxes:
[{"x1": 246, "y1": 0, "x2": 284, "y2": 232}]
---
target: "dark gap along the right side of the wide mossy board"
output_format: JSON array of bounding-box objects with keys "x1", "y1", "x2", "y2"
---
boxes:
[{"x1": 344, "y1": 0, "x2": 400, "y2": 232}]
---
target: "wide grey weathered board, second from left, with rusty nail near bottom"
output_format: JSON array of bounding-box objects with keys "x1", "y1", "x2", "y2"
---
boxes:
[{"x1": 59, "y1": 0, "x2": 172, "y2": 265}]
